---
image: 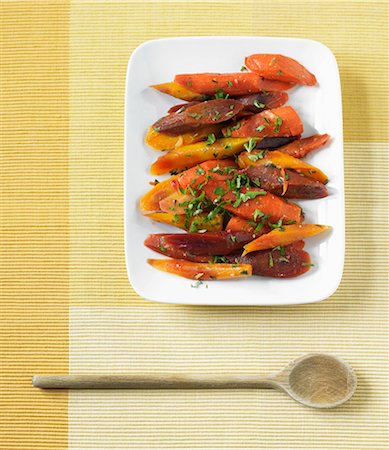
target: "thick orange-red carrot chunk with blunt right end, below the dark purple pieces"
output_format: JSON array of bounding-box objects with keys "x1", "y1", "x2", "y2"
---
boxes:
[{"x1": 223, "y1": 106, "x2": 304, "y2": 138}]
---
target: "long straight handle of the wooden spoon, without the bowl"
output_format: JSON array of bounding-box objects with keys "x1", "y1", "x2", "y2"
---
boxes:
[{"x1": 32, "y1": 374, "x2": 278, "y2": 389}]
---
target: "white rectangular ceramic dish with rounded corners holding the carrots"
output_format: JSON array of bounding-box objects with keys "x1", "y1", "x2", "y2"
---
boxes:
[{"x1": 124, "y1": 36, "x2": 345, "y2": 305}]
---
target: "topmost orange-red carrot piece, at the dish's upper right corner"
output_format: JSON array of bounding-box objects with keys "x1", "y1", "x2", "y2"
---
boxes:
[{"x1": 245, "y1": 54, "x2": 316, "y2": 86}]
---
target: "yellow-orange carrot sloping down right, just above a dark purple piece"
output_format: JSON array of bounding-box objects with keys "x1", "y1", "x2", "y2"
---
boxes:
[{"x1": 238, "y1": 150, "x2": 328, "y2": 184}]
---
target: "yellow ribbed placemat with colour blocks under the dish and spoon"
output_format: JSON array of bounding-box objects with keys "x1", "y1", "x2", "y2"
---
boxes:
[{"x1": 0, "y1": 0, "x2": 388, "y2": 450}]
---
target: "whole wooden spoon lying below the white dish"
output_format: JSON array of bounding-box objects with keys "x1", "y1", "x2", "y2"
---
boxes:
[{"x1": 32, "y1": 353, "x2": 357, "y2": 408}]
